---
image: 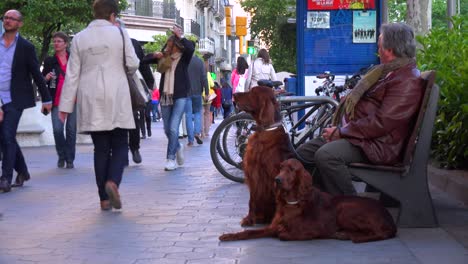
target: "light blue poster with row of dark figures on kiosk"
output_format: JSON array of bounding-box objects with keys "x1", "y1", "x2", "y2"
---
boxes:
[{"x1": 353, "y1": 10, "x2": 377, "y2": 43}]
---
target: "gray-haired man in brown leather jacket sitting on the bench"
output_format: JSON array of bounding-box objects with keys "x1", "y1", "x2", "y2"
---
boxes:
[{"x1": 297, "y1": 23, "x2": 424, "y2": 195}]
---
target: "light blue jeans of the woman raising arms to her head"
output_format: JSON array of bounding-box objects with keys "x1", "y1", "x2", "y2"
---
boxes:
[{"x1": 161, "y1": 97, "x2": 187, "y2": 160}]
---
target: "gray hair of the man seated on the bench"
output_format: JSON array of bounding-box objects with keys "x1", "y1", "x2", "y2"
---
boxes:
[{"x1": 380, "y1": 23, "x2": 416, "y2": 58}]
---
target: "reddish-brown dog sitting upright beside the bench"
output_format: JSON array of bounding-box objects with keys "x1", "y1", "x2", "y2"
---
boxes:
[{"x1": 234, "y1": 86, "x2": 294, "y2": 226}]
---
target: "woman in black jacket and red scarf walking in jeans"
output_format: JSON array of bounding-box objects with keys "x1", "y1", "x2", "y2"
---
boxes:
[{"x1": 42, "y1": 32, "x2": 76, "y2": 169}]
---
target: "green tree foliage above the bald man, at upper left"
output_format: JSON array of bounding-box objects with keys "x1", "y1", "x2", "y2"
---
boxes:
[{"x1": 0, "y1": 0, "x2": 127, "y2": 63}]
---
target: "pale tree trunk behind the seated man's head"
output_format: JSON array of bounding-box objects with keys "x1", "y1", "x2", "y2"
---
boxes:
[{"x1": 406, "y1": 0, "x2": 432, "y2": 35}]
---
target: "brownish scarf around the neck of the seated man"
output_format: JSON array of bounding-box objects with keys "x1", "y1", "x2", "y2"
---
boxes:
[{"x1": 332, "y1": 58, "x2": 416, "y2": 126}]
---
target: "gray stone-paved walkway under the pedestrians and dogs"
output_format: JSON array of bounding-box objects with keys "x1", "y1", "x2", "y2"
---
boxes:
[{"x1": 0, "y1": 120, "x2": 468, "y2": 264}]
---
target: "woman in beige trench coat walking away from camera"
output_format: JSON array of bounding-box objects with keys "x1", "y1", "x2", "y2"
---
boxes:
[{"x1": 59, "y1": 0, "x2": 139, "y2": 210}]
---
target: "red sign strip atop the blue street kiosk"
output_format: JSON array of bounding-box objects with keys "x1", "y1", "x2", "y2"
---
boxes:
[{"x1": 307, "y1": 0, "x2": 375, "y2": 10}]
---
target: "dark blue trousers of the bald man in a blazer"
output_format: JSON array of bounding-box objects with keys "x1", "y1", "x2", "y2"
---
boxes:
[{"x1": 0, "y1": 103, "x2": 28, "y2": 184}]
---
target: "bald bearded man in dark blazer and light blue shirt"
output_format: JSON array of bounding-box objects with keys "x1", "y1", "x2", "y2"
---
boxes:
[{"x1": 0, "y1": 10, "x2": 52, "y2": 192}]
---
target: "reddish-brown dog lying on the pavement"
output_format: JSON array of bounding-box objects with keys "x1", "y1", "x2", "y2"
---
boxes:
[{"x1": 219, "y1": 159, "x2": 397, "y2": 243}]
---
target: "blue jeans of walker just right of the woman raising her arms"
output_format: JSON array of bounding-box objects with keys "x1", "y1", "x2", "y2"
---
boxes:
[{"x1": 185, "y1": 95, "x2": 202, "y2": 143}]
